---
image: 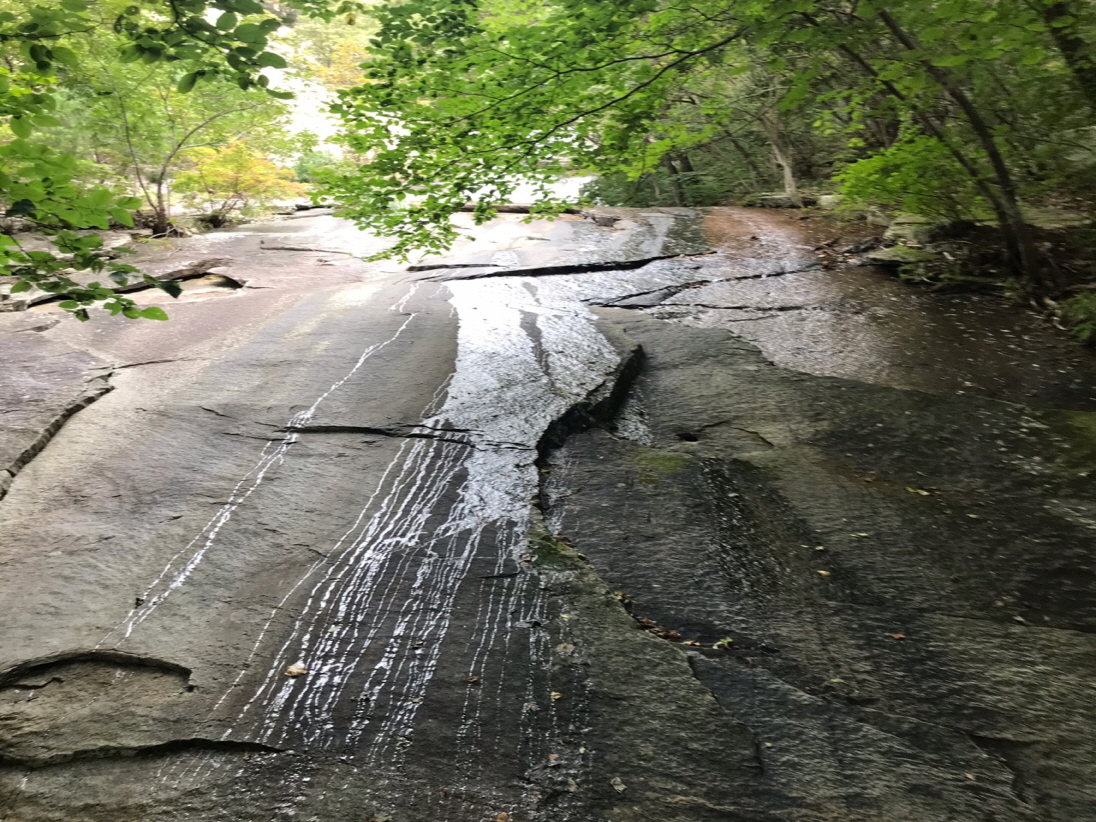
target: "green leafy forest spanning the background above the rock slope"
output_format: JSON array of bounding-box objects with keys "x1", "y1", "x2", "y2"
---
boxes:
[{"x1": 0, "y1": 0, "x2": 1096, "y2": 339}]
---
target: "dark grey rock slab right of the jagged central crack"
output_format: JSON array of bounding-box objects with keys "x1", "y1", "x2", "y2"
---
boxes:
[{"x1": 549, "y1": 311, "x2": 1096, "y2": 820}]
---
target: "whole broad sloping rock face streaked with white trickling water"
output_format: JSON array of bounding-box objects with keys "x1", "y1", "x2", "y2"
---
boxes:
[{"x1": 0, "y1": 209, "x2": 1096, "y2": 822}]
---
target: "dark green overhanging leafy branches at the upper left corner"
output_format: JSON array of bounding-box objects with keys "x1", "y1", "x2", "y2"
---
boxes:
[{"x1": 0, "y1": 0, "x2": 359, "y2": 319}]
